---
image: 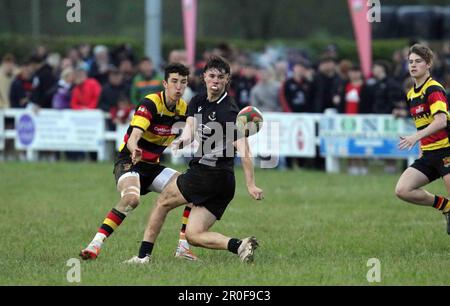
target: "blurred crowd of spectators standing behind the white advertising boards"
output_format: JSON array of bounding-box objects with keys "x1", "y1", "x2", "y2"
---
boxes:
[{"x1": 0, "y1": 42, "x2": 450, "y2": 169}]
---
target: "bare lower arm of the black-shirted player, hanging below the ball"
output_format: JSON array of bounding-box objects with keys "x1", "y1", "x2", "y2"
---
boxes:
[{"x1": 234, "y1": 137, "x2": 264, "y2": 200}]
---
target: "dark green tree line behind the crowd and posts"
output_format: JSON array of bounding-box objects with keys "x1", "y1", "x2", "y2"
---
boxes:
[{"x1": 0, "y1": 0, "x2": 448, "y2": 40}]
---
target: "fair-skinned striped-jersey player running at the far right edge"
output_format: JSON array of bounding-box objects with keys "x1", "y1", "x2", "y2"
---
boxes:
[{"x1": 395, "y1": 44, "x2": 450, "y2": 235}]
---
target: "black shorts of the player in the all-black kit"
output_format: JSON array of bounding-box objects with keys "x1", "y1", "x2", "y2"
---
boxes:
[{"x1": 177, "y1": 165, "x2": 236, "y2": 220}]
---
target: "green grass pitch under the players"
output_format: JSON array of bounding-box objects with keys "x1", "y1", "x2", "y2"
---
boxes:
[{"x1": 0, "y1": 163, "x2": 450, "y2": 286}]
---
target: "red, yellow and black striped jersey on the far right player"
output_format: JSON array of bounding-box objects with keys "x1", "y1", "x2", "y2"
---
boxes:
[{"x1": 407, "y1": 77, "x2": 450, "y2": 151}]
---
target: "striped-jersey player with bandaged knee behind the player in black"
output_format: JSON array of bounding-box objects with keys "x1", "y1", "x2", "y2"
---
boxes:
[{"x1": 80, "y1": 64, "x2": 197, "y2": 260}]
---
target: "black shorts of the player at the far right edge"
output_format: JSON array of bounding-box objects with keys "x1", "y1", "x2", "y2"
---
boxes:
[{"x1": 411, "y1": 148, "x2": 450, "y2": 182}]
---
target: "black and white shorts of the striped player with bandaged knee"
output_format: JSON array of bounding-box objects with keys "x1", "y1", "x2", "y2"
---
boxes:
[{"x1": 113, "y1": 153, "x2": 176, "y2": 195}]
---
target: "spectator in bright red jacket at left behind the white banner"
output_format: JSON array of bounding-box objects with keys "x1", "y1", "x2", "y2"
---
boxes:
[{"x1": 70, "y1": 67, "x2": 102, "y2": 110}]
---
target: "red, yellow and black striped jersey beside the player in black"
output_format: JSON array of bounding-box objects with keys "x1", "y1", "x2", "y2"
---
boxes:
[{"x1": 119, "y1": 91, "x2": 187, "y2": 163}]
